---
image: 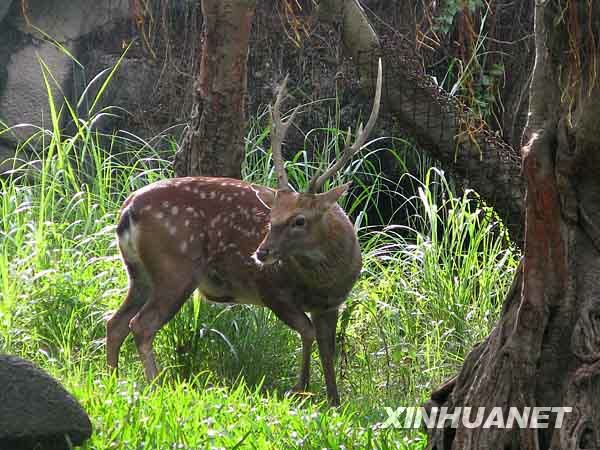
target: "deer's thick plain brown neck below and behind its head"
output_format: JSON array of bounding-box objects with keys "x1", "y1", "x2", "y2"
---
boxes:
[{"x1": 288, "y1": 208, "x2": 362, "y2": 296}]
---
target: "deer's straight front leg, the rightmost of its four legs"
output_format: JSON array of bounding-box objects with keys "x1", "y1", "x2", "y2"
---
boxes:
[{"x1": 311, "y1": 308, "x2": 340, "y2": 406}]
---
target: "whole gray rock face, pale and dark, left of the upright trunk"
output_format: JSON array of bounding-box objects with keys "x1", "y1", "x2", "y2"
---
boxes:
[{"x1": 0, "y1": 0, "x2": 200, "y2": 162}]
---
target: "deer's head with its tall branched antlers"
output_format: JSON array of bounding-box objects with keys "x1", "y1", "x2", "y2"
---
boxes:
[{"x1": 254, "y1": 61, "x2": 382, "y2": 264}]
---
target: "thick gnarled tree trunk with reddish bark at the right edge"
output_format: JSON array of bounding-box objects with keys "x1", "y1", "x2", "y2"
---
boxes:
[{"x1": 427, "y1": 0, "x2": 600, "y2": 450}]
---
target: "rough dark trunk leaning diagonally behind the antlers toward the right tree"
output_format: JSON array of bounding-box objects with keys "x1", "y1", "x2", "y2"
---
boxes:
[{"x1": 320, "y1": 0, "x2": 525, "y2": 245}]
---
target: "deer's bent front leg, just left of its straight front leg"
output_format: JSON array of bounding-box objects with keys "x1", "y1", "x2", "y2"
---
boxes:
[{"x1": 267, "y1": 301, "x2": 315, "y2": 392}]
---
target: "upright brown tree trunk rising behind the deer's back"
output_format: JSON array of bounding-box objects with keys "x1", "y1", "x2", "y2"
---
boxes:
[{"x1": 175, "y1": 0, "x2": 255, "y2": 178}]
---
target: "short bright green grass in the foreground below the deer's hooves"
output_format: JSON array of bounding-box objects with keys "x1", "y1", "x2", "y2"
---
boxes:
[{"x1": 64, "y1": 371, "x2": 422, "y2": 449}]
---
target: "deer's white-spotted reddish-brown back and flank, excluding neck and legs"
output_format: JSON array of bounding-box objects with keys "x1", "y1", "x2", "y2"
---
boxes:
[{"x1": 118, "y1": 177, "x2": 274, "y2": 303}]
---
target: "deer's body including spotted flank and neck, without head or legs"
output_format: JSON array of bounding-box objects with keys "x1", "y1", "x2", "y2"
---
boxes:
[{"x1": 118, "y1": 177, "x2": 361, "y2": 312}]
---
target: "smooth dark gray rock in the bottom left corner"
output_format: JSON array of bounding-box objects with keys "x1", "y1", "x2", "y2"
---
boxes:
[{"x1": 0, "y1": 355, "x2": 92, "y2": 450}]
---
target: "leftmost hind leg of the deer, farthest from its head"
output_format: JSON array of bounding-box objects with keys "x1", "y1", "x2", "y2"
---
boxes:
[{"x1": 106, "y1": 262, "x2": 152, "y2": 370}]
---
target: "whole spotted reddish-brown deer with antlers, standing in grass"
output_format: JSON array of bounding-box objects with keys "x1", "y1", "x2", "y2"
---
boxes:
[{"x1": 106, "y1": 62, "x2": 381, "y2": 405}]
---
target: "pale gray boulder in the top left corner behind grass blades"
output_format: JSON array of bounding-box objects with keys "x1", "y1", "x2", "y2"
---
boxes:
[{"x1": 0, "y1": 0, "x2": 131, "y2": 174}]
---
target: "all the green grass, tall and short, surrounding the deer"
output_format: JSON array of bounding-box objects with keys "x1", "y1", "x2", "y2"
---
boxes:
[{"x1": 0, "y1": 61, "x2": 518, "y2": 449}]
